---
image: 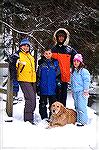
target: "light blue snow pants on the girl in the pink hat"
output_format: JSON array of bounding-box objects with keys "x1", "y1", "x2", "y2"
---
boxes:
[{"x1": 73, "y1": 91, "x2": 88, "y2": 125}]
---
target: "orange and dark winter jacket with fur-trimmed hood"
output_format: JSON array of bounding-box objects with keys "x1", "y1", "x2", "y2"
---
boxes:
[{"x1": 52, "y1": 28, "x2": 77, "y2": 82}]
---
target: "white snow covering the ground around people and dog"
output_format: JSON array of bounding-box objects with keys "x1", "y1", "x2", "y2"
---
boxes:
[{"x1": 0, "y1": 88, "x2": 99, "y2": 150}]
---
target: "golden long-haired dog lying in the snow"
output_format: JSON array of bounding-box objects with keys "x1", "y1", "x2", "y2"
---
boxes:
[{"x1": 49, "y1": 101, "x2": 77, "y2": 128}]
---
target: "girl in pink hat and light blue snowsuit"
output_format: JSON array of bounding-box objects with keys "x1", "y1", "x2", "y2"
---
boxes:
[{"x1": 71, "y1": 54, "x2": 90, "y2": 126}]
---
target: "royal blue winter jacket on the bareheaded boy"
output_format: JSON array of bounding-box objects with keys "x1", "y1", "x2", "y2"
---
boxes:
[{"x1": 37, "y1": 58, "x2": 60, "y2": 95}]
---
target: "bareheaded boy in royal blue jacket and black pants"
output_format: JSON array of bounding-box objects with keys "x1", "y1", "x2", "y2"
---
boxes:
[{"x1": 37, "y1": 48, "x2": 60, "y2": 119}]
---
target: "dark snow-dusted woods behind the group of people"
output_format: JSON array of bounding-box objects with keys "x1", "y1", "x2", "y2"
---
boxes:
[{"x1": 0, "y1": 0, "x2": 99, "y2": 76}]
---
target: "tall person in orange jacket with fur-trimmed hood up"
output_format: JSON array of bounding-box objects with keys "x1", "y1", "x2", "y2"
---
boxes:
[{"x1": 52, "y1": 28, "x2": 77, "y2": 106}]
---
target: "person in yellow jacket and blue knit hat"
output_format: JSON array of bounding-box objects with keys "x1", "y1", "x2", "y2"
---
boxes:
[{"x1": 10, "y1": 38, "x2": 36, "y2": 124}]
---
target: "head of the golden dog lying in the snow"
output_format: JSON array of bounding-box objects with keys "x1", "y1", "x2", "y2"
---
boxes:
[{"x1": 51, "y1": 101, "x2": 66, "y2": 115}]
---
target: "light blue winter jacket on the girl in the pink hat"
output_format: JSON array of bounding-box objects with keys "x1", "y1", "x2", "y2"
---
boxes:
[{"x1": 71, "y1": 68, "x2": 90, "y2": 92}]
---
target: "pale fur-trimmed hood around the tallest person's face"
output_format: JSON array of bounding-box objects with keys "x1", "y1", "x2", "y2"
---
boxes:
[{"x1": 53, "y1": 28, "x2": 70, "y2": 45}]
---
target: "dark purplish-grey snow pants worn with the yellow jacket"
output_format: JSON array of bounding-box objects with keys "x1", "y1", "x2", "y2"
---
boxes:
[{"x1": 19, "y1": 81, "x2": 36, "y2": 123}]
